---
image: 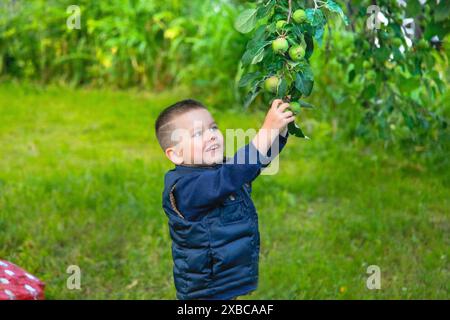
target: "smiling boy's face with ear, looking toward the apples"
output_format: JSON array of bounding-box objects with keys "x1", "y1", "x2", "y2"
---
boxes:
[{"x1": 166, "y1": 108, "x2": 224, "y2": 165}]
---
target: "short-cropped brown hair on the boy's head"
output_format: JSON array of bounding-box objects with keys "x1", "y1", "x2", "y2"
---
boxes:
[{"x1": 155, "y1": 99, "x2": 207, "y2": 151}]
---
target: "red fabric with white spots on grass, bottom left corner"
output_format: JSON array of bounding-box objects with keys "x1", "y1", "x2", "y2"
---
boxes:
[{"x1": 0, "y1": 260, "x2": 45, "y2": 300}]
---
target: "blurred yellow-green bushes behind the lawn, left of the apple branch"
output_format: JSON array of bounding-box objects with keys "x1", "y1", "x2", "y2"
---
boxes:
[{"x1": 0, "y1": 0, "x2": 244, "y2": 104}]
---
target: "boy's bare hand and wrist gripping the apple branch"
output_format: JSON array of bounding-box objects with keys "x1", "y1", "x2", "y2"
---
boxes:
[{"x1": 252, "y1": 99, "x2": 295, "y2": 156}]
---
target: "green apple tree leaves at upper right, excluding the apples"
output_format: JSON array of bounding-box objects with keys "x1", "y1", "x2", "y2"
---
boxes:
[{"x1": 235, "y1": 0, "x2": 450, "y2": 139}]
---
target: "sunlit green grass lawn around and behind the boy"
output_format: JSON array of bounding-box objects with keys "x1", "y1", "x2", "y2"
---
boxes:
[{"x1": 0, "y1": 84, "x2": 450, "y2": 299}]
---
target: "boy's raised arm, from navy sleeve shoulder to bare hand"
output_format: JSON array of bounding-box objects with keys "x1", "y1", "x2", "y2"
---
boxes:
[{"x1": 175, "y1": 100, "x2": 294, "y2": 219}]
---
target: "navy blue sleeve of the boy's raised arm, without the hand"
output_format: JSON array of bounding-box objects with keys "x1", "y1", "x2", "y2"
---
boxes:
[{"x1": 174, "y1": 135, "x2": 287, "y2": 220}]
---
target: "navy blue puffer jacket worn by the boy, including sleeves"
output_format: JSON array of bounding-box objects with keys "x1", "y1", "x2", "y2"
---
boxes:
[{"x1": 163, "y1": 136, "x2": 287, "y2": 299}]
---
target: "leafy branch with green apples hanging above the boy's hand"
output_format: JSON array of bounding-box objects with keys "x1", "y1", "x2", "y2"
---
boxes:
[{"x1": 235, "y1": 0, "x2": 348, "y2": 139}]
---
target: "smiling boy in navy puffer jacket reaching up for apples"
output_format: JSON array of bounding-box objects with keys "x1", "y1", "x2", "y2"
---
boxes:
[{"x1": 155, "y1": 99, "x2": 294, "y2": 299}]
